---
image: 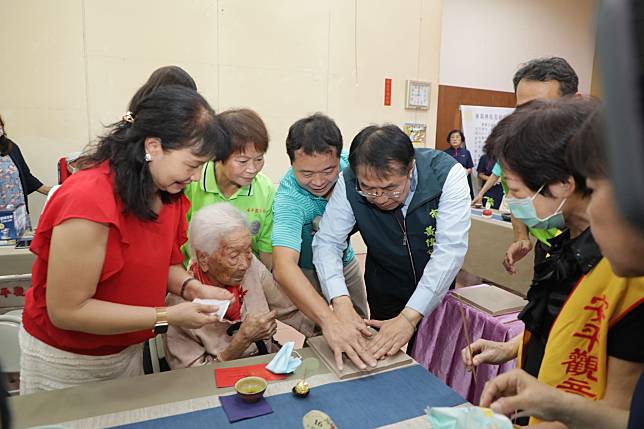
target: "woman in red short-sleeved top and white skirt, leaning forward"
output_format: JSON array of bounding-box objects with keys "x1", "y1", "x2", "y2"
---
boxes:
[{"x1": 20, "y1": 86, "x2": 232, "y2": 393}]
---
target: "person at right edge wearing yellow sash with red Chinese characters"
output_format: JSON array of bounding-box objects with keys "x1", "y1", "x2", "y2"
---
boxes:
[{"x1": 481, "y1": 102, "x2": 644, "y2": 429}]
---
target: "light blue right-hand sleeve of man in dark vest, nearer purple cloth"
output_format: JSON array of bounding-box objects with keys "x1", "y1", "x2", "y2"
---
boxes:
[{"x1": 407, "y1": 164, "x2": 471, "y2": 315}]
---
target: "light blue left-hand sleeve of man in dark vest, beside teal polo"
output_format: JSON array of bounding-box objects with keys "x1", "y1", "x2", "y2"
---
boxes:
[{"x1": 313, "y1": 173, "x2": 354, "y2": 302}]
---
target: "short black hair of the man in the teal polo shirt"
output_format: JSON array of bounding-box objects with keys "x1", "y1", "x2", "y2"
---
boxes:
[{"x1": 286, "y1": 113, "x2": 342, "y2": 164}]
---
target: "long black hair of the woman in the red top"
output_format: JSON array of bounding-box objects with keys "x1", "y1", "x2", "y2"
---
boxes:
[{"x1": 81, "y1": 85, "x2": 227, "y2": 220}]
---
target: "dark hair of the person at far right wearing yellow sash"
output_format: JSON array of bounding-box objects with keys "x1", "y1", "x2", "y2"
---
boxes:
[{"x1": 566, "y1": 109, "x2": 608, "y2": 179}]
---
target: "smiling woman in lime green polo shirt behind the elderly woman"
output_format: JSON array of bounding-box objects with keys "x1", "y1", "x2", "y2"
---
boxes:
[{"x1": 182, "y1": 109, "x2": 275, "y2": 269}]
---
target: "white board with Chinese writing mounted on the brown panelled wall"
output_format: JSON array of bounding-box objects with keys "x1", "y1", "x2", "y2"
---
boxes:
[{"x1": 461, "y1": 105, "x2": 514, "y2": 168}]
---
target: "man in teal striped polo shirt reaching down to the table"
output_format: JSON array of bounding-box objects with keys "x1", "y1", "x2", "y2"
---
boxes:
[{"x1": 272, "y1": 113, "x2": 375, "y2": 365}]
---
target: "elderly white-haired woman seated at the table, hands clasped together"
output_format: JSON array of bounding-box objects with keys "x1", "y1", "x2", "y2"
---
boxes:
[{"x1": 166, "y1": 203, "x2": 315, "y2": 369}]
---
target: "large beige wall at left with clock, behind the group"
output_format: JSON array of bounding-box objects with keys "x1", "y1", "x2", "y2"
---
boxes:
[{"x1": 0, "y1": 0, "x2": 442, "y2": 226}]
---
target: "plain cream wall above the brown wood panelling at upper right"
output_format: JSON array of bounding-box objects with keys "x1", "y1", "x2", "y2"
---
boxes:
[{"x1": 440, "y1": 0, "x2": 595, "y2": 93}]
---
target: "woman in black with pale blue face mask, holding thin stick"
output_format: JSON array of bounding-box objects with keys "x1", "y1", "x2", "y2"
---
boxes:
[{"x1": 462, "y1": 100, "x2": 601, "y2": 390}]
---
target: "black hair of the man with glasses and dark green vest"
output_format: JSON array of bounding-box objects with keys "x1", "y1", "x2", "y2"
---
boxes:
[{"x1": 349, "y1": 124, "x2": 415, "y2": 178}]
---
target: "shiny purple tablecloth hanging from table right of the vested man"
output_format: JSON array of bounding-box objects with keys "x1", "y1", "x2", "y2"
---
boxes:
[{"x1": 411, "y1": 285, "x2": 523, "y2": 404}]
